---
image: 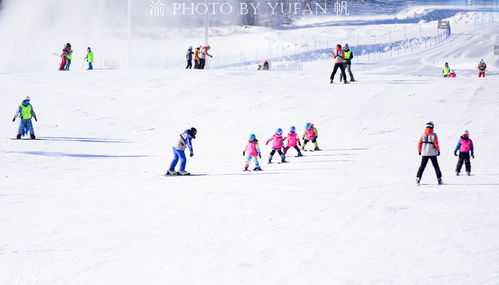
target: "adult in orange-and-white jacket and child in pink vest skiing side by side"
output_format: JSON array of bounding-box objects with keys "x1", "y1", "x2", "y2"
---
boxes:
[{"x1": 416, "y1": 122, "x2": 475, "y2": 185}]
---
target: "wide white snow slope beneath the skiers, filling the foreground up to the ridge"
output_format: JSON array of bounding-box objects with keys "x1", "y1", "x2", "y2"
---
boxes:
[{"x1": 0, "y1": 8, "x2": 499, "y2": 285}]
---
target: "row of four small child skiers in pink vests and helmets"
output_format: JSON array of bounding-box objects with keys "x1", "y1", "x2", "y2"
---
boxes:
[{"x1": 243, "y1": 123, "x2": 320, "y2": 171}]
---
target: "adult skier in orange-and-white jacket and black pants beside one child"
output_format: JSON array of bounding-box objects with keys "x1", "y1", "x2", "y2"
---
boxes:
[{"x1": 416, "y1": 122, "x2": 443, "y2": 185}]
